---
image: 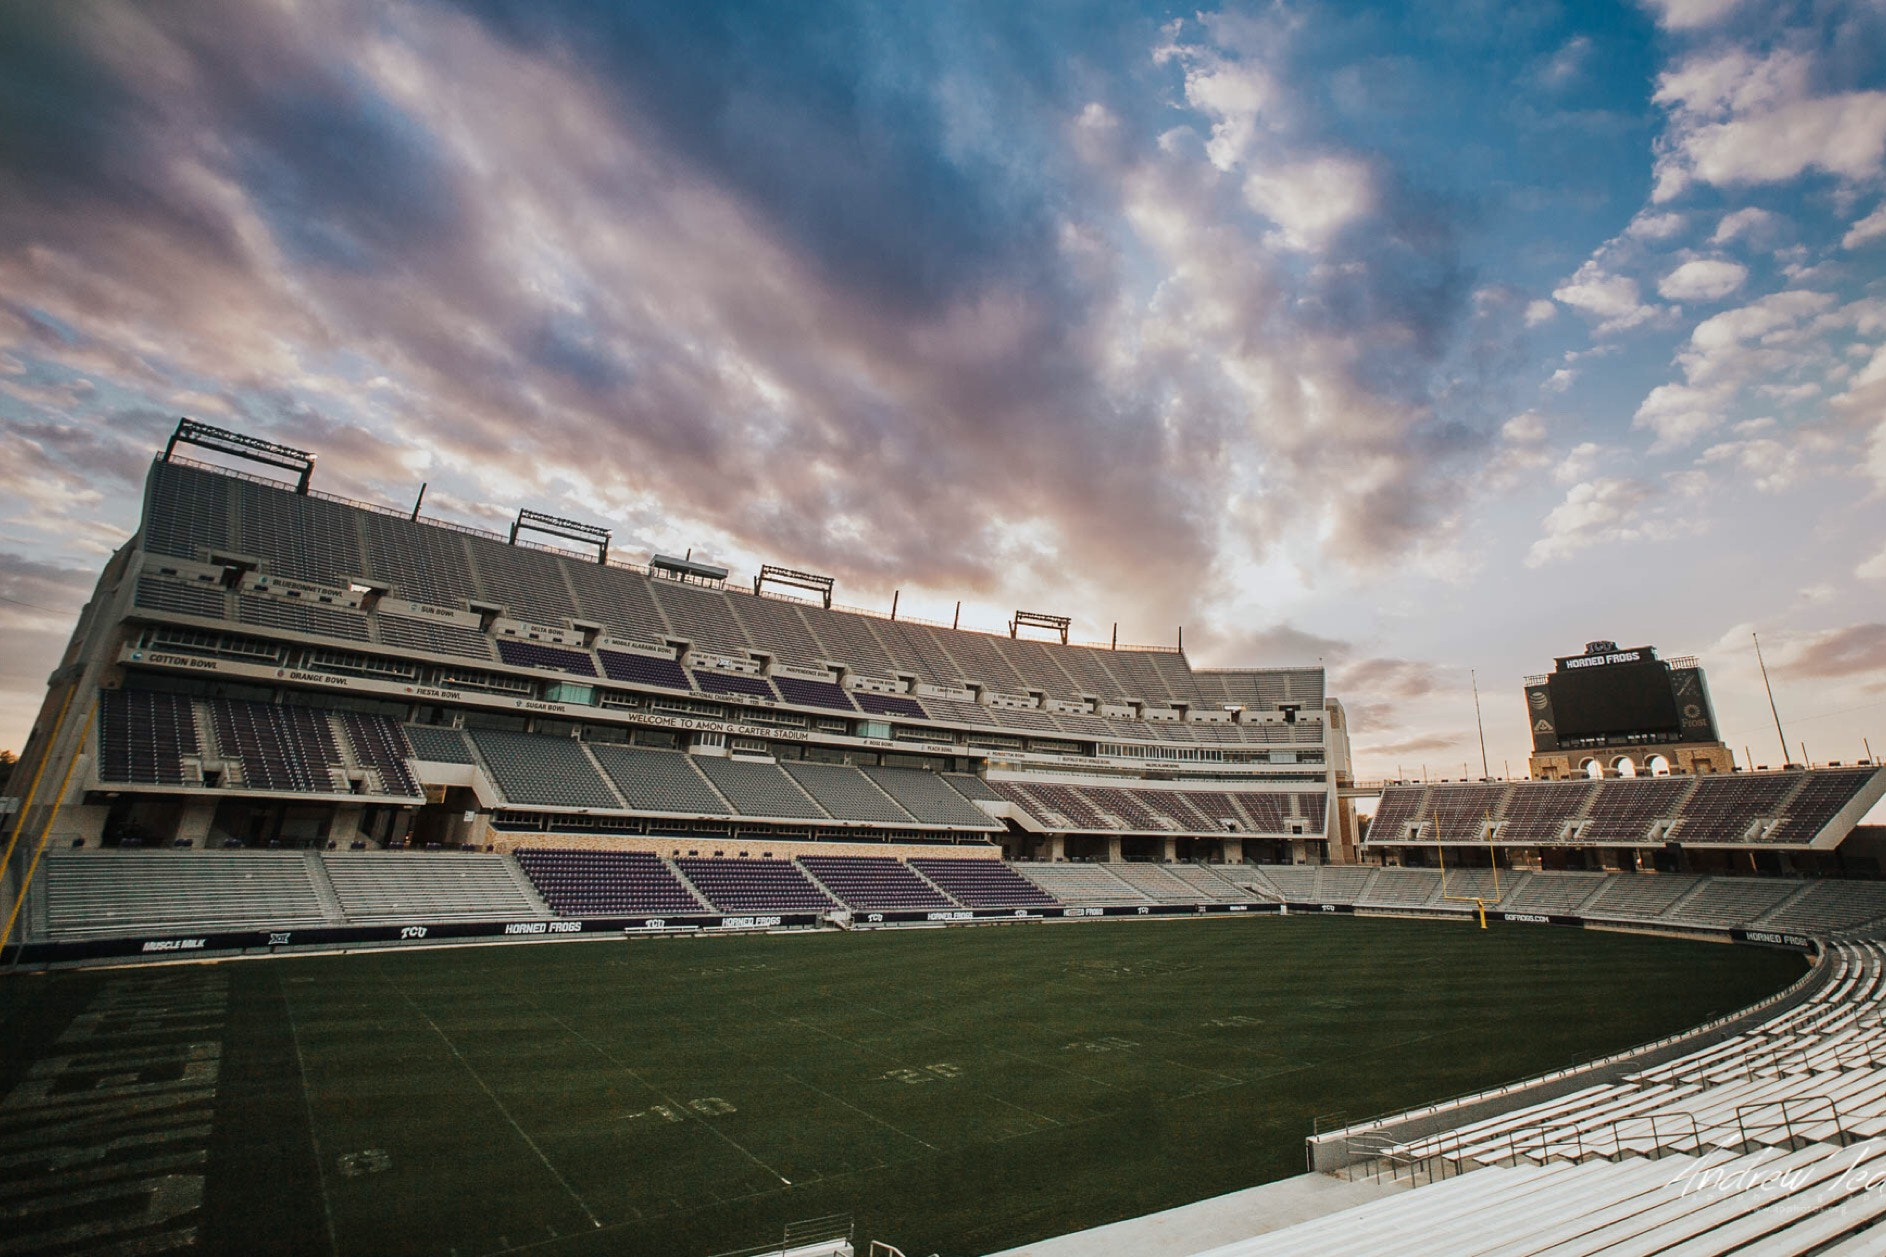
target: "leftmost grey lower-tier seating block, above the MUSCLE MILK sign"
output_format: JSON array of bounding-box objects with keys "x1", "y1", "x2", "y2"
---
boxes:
[{"x1": 40, "y1": 851, "x2": 328, "y2": 938}]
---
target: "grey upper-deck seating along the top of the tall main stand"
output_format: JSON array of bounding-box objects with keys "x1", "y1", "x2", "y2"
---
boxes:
[{"x1": 140, "y1": 464, "x2": 1322, "y2": 744}]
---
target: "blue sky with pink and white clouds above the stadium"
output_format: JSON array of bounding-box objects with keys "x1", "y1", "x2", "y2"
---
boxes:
[{"x1": 0, "y1": 0, "x2": 1886, "y2": 778}]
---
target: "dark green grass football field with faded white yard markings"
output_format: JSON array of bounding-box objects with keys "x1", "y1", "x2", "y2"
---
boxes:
[{"x1": 0, "y1": 917, "x2": 1803, "y2": 1257}]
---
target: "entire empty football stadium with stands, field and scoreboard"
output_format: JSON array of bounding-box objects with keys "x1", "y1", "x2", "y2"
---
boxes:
[{"x1": 0, "y1": 419, "x2": 1886, "y2": 1257}]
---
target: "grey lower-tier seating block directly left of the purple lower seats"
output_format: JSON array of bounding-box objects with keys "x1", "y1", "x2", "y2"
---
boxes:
[{"x1": 321, "y1": 851, "x2": 543, "y2": 923}]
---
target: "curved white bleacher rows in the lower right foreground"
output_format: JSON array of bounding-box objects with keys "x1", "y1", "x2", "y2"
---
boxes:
[{"x1": 1320, "y1": 942, "x2": 1886, "y2": 1257}]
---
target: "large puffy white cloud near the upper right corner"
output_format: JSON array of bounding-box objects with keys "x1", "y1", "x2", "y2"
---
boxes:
[{"x1": 1652, "y1": 47, "x2": 1886, "y2": 204}]
